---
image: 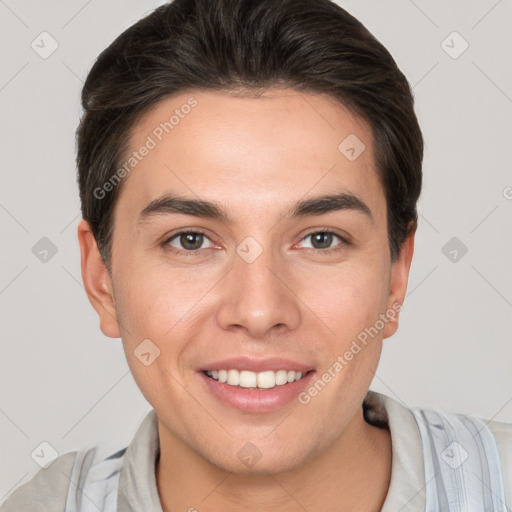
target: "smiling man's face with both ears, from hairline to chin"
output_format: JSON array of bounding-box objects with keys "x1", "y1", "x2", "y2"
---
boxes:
[{"x1": 79, "y1": 89, "x2": 412, "y2": 473}]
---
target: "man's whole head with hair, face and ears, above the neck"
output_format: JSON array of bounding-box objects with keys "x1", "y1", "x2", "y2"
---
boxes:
[{"x1": 77, "y1": 0, "x2": 423, "y2": 472}]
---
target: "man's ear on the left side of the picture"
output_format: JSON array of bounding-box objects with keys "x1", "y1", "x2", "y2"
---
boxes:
[{"x1": 78, "y1": 219, "x2": 121, "y2": 338}]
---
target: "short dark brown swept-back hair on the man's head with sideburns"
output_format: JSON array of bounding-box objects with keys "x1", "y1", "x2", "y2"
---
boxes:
[{"x1": 76, "y1": 0, "x2": 423, "y2": 271}]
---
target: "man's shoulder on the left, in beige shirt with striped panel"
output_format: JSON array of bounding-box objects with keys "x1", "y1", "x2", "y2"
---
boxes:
[{"x1": 0, "y1": 444, "x2": 126, "y2": 512}]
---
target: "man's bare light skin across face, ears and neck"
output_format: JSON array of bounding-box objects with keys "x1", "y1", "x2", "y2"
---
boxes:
[{"x1": 78, "y1": 89, "x2": 414, "y2": 512}]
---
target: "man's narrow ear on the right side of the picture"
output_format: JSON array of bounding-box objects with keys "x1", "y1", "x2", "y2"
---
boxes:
[{"x1": 383, "y1": 228, "x2": 416, "y2": 339}]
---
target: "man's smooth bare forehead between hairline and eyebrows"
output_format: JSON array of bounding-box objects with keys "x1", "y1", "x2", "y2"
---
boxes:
[{"x1": 115, "y1": 89, "x2": 384, "y2": 222}]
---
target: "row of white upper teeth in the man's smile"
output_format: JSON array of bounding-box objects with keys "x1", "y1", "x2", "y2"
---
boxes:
[{"x1": 206, "y1": 369, "x2": 304, "y2": 389}]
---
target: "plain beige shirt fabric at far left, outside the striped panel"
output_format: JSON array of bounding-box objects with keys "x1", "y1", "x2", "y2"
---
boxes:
[{"x1": 1, "y1": 451, "x2": 78, "y2": 512}]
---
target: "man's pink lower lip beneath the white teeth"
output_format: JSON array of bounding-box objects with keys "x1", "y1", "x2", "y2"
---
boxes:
[{"x1": 198, "y1": 371, "x2": 315, "y2": 413}]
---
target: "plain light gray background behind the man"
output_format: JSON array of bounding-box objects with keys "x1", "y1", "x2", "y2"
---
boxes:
[{"x1": 0, "y1": 0, "x2": 512, "y2": 499}]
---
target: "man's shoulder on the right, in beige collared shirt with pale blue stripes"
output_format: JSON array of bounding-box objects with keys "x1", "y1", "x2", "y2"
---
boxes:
[{"x1": 363, "y1": 391, "x2": 512, "y2": 510}]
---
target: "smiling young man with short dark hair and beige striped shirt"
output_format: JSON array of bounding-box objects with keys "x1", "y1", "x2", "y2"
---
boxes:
[{"x1": 3, "y1": 0, "x2": 512, "y2": 512}]
